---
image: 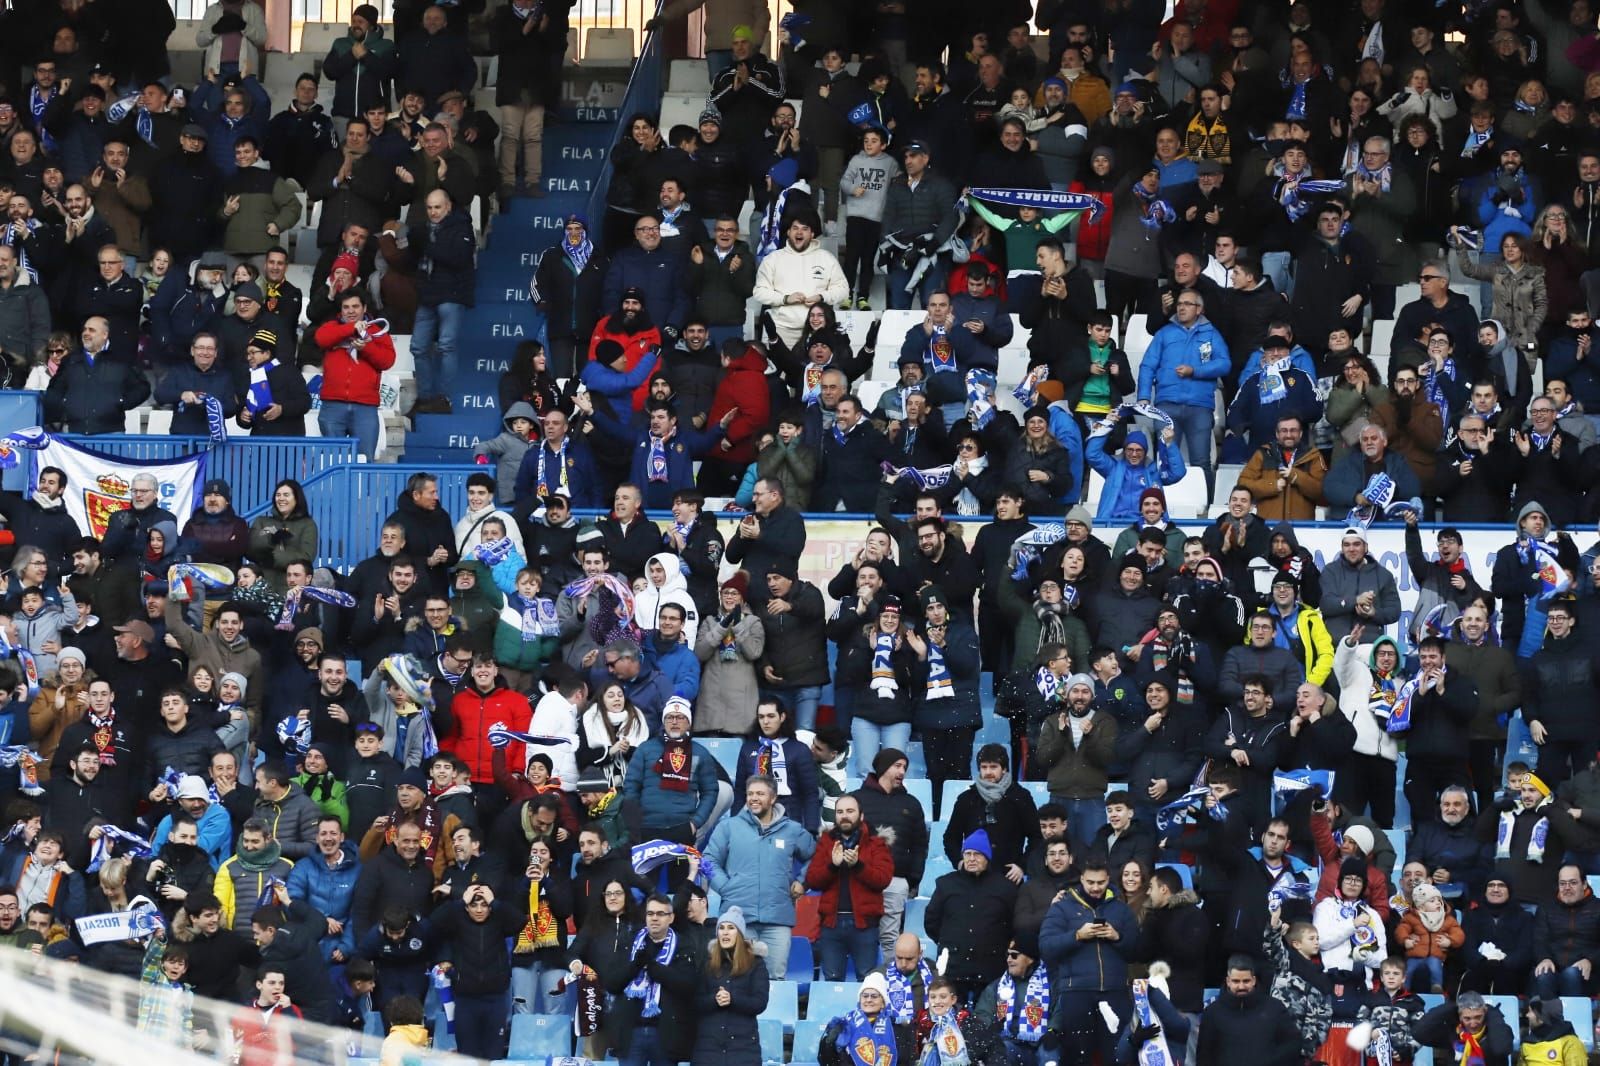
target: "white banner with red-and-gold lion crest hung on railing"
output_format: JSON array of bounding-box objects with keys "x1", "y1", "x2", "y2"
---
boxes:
[{"x1": 29, "y1": 437, "x2": 205, "y2": 536}]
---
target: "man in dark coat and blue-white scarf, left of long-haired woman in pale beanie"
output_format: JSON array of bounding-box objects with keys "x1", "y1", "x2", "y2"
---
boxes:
[{"x1": 606, "y1": 889, "x2": 700, "y2": 1066}]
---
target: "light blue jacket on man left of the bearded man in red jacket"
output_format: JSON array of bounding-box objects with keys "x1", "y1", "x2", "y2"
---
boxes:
[{"x1": 707, "y1": 806, "x2": 816, "y2": 925}]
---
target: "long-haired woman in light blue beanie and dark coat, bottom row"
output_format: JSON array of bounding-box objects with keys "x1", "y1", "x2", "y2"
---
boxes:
[{"x1": 690, "y1": 908, "x2": 768, "y2": 1066}]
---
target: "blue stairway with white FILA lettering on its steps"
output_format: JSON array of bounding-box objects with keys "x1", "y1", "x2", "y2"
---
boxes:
[{"x1": 402, "y1": 117, "x2": 616, "y2": 464}]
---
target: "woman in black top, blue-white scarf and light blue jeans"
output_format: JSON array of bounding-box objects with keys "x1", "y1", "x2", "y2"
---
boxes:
[{"x1": 827, "y1": 595, "x2": 926, "y2": 776}]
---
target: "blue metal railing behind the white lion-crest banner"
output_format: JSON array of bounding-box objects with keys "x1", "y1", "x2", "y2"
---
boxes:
[{"x1": 62, "y1": 434, "x2": 360, "y2": 514}]
